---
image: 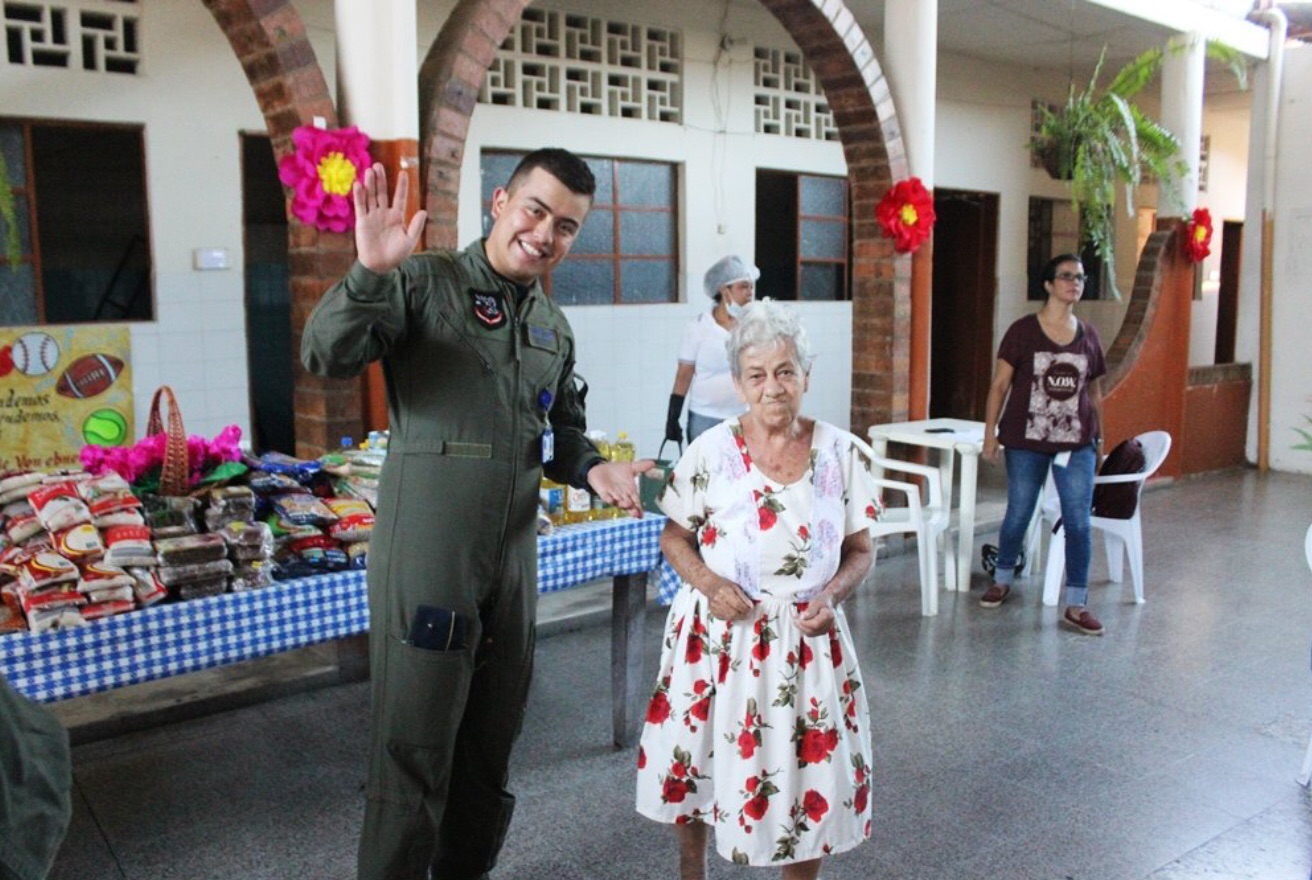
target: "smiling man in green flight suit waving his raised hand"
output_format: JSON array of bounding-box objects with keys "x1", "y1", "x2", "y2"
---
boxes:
[{"x1": 300, "y1": 148, "x2": 652, "y2": 880}]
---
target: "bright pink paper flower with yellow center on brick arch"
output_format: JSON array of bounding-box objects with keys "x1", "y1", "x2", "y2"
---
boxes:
[{"x1": 278, "y1": 126, "x2": 370, "y2": 232}]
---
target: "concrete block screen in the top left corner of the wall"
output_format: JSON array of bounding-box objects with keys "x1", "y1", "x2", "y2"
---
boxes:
[{"x1": 0, "y1": 0, "x2": 142, "y2": 73}]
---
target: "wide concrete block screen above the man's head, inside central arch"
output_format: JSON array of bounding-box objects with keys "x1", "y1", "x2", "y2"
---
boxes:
[{"x1": 479, "y1": 7, "x2": 684, "y2": 123}]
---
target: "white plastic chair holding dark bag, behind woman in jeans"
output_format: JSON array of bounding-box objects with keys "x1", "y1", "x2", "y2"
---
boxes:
[{"x1": 1043, "y1": 431, "x2": 1170, "y2": 605}]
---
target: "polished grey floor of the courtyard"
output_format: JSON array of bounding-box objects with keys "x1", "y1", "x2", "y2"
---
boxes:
[{"x1": 38, "y1": 471, "x2": 1312, "y2": 880}]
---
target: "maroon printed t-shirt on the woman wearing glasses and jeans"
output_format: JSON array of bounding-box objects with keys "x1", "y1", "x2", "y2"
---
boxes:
[{"x1": 997, "y1": 315, "x2": 1107, "y2": 452}]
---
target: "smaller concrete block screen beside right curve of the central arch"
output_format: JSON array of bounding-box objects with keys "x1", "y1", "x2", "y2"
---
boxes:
[{"x1": 753, "y1": 46, "x2": 838, "y2": 140}]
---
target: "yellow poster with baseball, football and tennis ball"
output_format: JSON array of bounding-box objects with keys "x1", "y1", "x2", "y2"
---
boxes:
[{"x1": 0, "y1": 324, "x2": 136, "y2": 472}]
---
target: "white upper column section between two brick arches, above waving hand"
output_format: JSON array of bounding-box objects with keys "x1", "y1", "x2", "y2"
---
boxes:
[{"x1": 333, "y1": 0, "x2": 419, "y2": 140}]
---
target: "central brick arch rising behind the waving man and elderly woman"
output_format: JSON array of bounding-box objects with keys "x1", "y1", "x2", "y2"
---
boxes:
[{"x1": 419, "y1": 0, "x2": 911, "y2": 431}]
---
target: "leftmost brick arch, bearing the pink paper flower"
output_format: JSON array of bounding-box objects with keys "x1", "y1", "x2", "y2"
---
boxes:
[{"x1": 202, "y1": 0, "x2": 362, "y2": 456}]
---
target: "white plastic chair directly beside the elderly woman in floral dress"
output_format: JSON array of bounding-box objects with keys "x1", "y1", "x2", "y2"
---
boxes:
[{"x1": 851, "y1": 434, "x2": 953, "y2": 618}]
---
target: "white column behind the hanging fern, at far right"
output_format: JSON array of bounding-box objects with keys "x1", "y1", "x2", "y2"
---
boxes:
[{"x1": 1157, "y1": 34, "x2": 1207, "y2": 216}]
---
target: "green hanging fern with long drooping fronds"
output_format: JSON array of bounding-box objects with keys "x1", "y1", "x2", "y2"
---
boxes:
[{"x1": 1030, "y1": 41, "x2": 1248, "y2": 299}]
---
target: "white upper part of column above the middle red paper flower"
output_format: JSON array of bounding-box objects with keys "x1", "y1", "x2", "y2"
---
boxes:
[{"x1": 879, "y1": 0, "x2": 938, "y2": 183}]
